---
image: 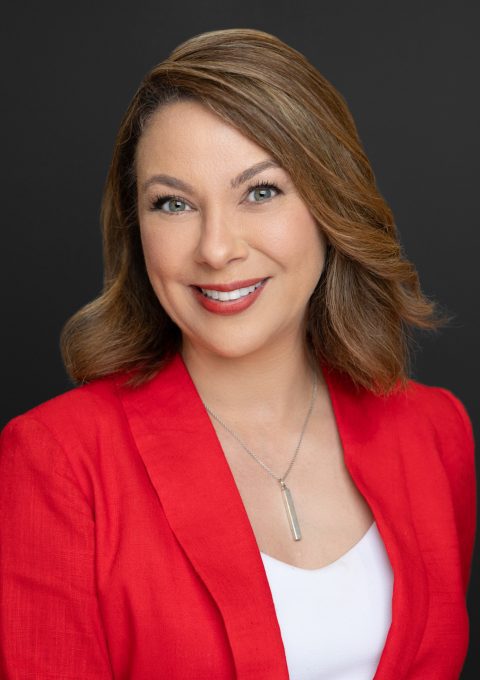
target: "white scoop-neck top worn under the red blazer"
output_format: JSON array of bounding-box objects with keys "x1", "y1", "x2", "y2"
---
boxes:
[{"x1": 261, "y1": 522, "x2": 393, "y2": 680}]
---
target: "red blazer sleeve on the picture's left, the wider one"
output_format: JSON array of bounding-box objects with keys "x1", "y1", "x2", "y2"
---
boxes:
[{"x1": 0, "y1": 415, "x2": 113, "y2": 680}]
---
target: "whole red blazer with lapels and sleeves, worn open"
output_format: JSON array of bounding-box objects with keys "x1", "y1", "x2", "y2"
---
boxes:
[{"x1": 0, "y1": 356, "x2": 475, "y2": 680}]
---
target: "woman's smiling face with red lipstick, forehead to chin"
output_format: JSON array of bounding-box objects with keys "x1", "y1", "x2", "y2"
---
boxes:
[{"x1": 136, "y1": 101, "x2": 325, "y2": 358}]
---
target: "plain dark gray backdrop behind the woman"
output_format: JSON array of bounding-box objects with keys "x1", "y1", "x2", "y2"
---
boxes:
[{"x1": 0, "y1": 0, "x2": 480, "y2": 678}]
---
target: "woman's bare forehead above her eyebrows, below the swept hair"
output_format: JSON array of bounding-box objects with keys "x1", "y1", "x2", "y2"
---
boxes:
[{"x1": 136, "y1": 101, "x2": 271, "y2": 180}]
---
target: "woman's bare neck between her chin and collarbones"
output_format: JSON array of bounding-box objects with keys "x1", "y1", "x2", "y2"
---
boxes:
[{"x1": 182, "y1": 334, "x2": 321, "y2": 427}]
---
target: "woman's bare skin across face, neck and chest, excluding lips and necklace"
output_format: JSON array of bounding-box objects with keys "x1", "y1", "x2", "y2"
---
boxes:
[{"x1": 136, "y1": 101, "x2": 372, "y2": 568}]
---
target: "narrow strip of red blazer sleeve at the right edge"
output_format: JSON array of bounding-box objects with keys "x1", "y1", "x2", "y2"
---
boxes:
[{"x1": 438, "y1": 388, "x2": 477, "y2": 593}]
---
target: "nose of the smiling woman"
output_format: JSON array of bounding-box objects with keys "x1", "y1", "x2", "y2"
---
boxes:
[{"x1": 195, "y1": 210, "x2": 248, "y2": 269}]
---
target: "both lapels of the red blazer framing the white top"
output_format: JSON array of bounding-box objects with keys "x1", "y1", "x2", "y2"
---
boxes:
[{"x1": 120, "y1": 355, "x2": 428, "y2": 680}]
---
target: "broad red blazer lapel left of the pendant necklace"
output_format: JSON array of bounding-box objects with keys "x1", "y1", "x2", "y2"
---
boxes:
[{"x1": 120, "y1": 355, "x2": 288, "y2": 680}]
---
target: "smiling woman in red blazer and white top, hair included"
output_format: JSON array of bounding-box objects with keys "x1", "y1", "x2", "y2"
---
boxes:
[{"x1": 0, "y1": 30, "x2": 475, "y2": 680}]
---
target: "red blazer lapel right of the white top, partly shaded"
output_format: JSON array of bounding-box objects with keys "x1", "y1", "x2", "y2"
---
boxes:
[{"x1": 323, "y1": 368, "x2": 428, "y2": 680}]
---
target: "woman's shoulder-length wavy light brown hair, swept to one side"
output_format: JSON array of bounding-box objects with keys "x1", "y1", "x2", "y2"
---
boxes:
[{"x1": 61, "y1": 29, "x2": 443, "y2": 394}]
